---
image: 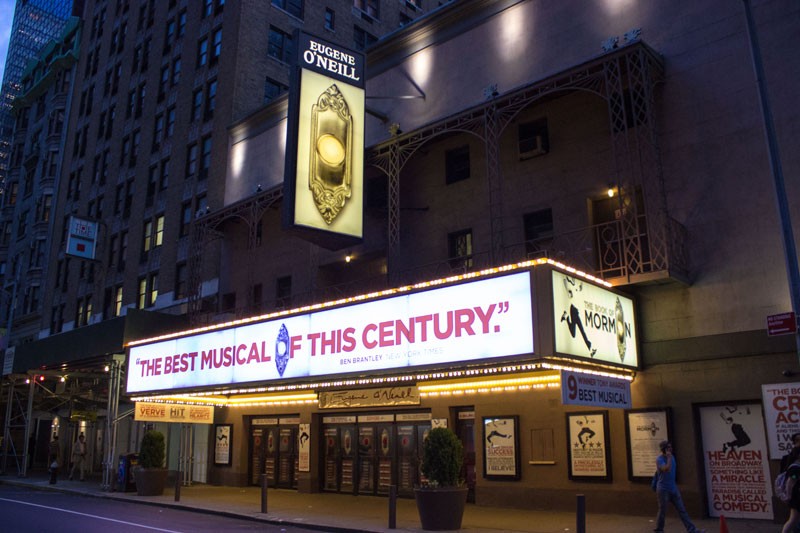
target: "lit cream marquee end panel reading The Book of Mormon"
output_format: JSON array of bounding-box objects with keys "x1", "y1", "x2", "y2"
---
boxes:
[{"x1": 553, "y1": 270, "x2": 639, "y2": 368}]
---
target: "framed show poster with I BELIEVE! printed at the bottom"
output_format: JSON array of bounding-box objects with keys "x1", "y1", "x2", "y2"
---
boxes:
[{"x1": 483, "y1": 416, "x2": 520, "y2": 480}]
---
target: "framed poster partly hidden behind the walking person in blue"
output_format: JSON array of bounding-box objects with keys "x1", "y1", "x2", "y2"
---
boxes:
[{"x1": 625, "y1": 407, "x2": 672, "y2": 481}]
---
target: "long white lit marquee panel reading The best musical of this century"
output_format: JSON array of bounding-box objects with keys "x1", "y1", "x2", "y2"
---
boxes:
[{"x1": 127, "y1": 271, "x2": 533, "y2": 393}]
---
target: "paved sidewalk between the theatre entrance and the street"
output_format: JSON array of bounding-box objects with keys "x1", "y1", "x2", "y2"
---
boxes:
[{"x1": 0, "y1": 473, "x2": 780, "y2": 533}]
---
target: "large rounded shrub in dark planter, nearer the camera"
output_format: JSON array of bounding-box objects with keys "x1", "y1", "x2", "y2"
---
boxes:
[{"x1": 414, "y1": 427, "x2": 468, "y2": 531}]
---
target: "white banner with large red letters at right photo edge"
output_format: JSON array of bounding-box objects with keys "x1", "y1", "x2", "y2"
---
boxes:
[{"x1": 761, "y1": 382, "x2": 800, "y2": 459}]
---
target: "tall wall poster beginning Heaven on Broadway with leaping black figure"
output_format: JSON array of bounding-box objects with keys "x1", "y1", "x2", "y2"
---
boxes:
[{"x1": 696, "y1": 403, "x2": 773, "y2": 520}]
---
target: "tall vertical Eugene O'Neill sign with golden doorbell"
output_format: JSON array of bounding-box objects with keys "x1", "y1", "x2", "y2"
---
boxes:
[{"x1": 284, "y1": 31, "x2": 365, "y2": 249}]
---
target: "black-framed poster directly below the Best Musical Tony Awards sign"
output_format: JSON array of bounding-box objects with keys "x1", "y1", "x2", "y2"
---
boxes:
[{"x1": 567, "y1": 411, "x2": 611, "y2": 481}]
